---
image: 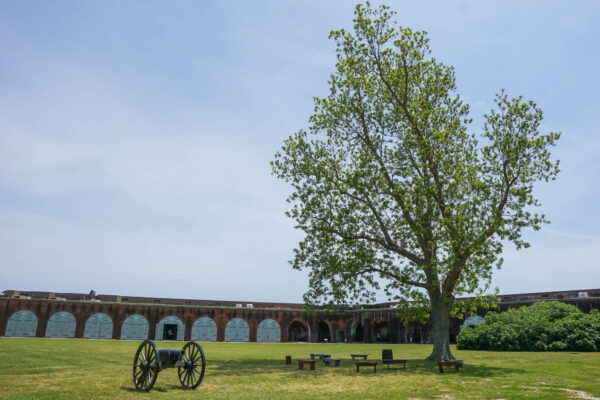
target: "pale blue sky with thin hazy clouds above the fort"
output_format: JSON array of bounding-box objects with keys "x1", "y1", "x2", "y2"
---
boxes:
[{"x1": 0, "y1": 0, "x2": 600, "y2": 302}]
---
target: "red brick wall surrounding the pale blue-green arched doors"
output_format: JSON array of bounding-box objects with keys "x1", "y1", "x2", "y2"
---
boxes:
[{"x1": 0, "y1": 289, "x2": 600, "y2": 342}]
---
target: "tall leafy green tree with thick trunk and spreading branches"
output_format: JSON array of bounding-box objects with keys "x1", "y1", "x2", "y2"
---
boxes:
[{"x1": 272, "y1": 3, "x2": 560, "y2": 360}]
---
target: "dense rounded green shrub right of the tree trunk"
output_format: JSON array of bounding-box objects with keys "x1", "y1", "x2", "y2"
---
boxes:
[{"x1": 456, "y1": 301, "x2": 600, "y2": 351}]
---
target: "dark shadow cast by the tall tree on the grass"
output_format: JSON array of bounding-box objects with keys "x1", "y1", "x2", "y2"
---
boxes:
[{"x1": 206, "y1": 359, "x2": 527, "y2": 378}]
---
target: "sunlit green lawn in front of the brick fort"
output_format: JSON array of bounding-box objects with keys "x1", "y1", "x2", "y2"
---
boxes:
[{"x1": 0, "y1": 338, "x2": 600, "y2": 399}]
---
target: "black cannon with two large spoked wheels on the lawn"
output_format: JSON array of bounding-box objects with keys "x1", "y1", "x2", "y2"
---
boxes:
[{"x1": 133, "y1": 340, "x2": 206, "y2": 391}]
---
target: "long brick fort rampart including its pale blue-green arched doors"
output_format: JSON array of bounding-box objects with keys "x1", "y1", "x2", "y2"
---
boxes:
[{"x1": 0, "y1": 289, "x2": 600, "y2": 343}]
